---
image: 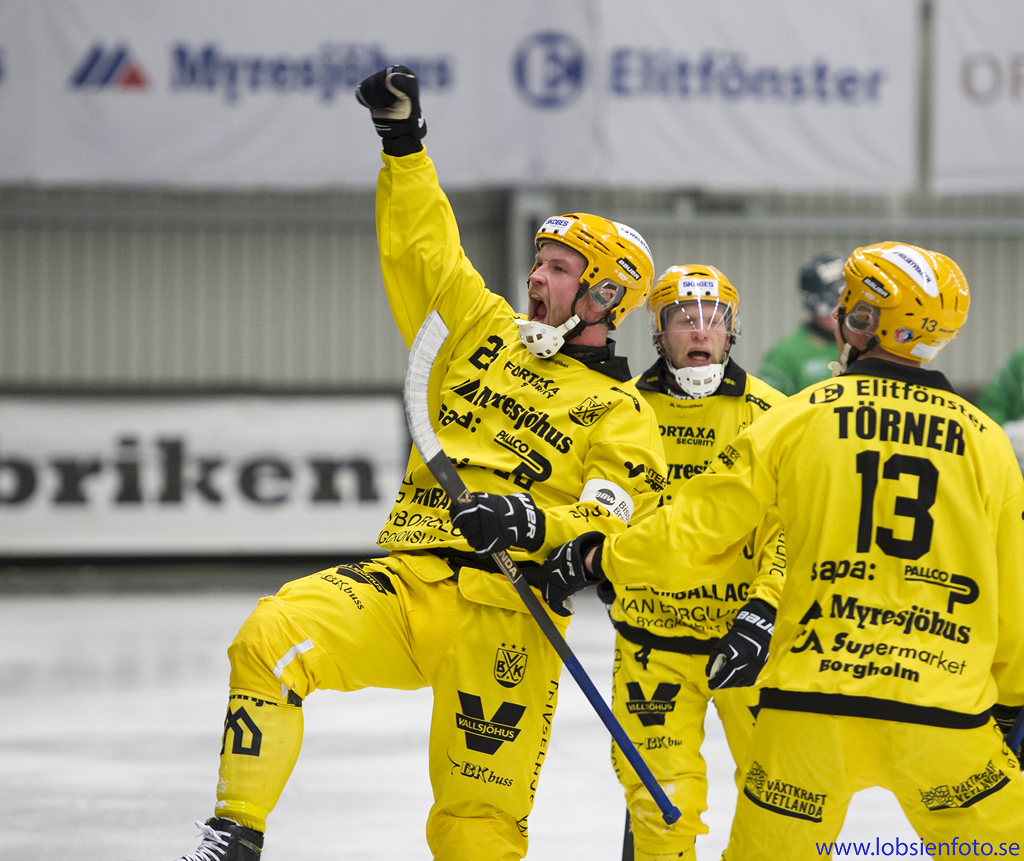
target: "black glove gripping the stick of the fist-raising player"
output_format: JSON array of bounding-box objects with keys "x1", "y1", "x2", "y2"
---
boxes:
[{"x1": 450, "y1": 493, "x2": 544, "y2": 556}]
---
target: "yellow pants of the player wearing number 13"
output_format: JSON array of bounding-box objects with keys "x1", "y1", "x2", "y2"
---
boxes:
[{"x1": 723, "y1": 708, "x2": 1024, "y2": 861}]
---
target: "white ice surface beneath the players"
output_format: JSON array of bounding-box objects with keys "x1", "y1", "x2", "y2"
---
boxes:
[{"x1": 0, "y1": 591, "x2": 915, "y2": 861}]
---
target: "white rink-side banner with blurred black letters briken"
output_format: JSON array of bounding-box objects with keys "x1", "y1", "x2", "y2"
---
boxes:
[{"x1": 0, "y1": 396, "x2": 410, "y2": 557}]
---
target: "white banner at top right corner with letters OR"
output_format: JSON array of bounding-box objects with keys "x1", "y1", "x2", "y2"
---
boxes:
[{"x1": 932, "y1": 0, "x2": 1024, "y2": 193}]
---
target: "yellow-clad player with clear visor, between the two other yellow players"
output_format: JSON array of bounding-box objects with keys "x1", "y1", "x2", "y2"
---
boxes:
[{"x1": 600, "y1": 265, "x2": 785, "y2": 861}]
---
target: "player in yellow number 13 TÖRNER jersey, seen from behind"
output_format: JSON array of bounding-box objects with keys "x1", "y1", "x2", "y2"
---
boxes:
[{"x1": 536, "y1": 242, "x2": 1024, "y2": 861}]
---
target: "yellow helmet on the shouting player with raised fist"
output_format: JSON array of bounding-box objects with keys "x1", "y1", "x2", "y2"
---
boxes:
[{"x1": 534, "y1": 212, "x2": 654, "y2": 329}]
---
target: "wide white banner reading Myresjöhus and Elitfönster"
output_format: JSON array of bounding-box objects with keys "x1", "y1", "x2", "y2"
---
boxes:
[{"x1": 0, "y1": 0, "x2": 918, "y2": 191}]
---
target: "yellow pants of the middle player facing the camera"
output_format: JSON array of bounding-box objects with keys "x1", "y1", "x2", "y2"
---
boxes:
[{"x1": 611, "y1": 634, "x2": 759, "y2": 861}]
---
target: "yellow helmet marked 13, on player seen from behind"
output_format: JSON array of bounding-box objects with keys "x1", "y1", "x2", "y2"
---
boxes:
[{"x1": 839, "y1": 242, "x2": 971, "y2": 361}]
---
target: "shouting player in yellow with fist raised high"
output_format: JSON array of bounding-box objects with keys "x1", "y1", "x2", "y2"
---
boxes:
[{"x1": 161, "y1": 67, "x2": 665, "y2": 861}]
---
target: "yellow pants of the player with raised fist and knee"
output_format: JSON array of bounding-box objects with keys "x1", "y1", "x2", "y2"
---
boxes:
[{"x1": 216, "y1": 554, "x2": 568, "y2": 861}]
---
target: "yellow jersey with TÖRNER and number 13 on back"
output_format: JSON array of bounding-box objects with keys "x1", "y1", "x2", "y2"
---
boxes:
[{"x1": 602, "y1": 358, "x2": 1024, "y2": 728}]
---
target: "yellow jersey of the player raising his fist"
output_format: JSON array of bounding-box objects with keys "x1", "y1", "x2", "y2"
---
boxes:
[{"x1": 377, "y1": 152, "x2": 665, "y2": 562}]
